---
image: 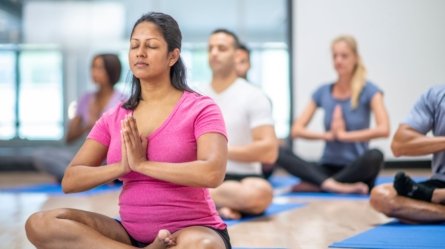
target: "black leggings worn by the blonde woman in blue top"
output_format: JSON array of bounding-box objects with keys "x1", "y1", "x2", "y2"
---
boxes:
[{"x1": 276, "y1": 147, "x2": 383, "y2": 189}]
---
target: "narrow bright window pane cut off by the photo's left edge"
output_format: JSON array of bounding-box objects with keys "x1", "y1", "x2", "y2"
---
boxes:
[{"x1": 0, "y1": 51, "x2": 16, "y2": 140}]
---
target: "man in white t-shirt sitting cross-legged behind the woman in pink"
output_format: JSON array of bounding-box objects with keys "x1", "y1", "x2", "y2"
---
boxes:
[{"x1": 199, "y1": 29, "x2": 278, "y2": 219}]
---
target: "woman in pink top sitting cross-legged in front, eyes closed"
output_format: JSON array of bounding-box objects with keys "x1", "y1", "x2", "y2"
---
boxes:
[{"x1": 26, "y1": 13, "x2": 231, "y2": 249}]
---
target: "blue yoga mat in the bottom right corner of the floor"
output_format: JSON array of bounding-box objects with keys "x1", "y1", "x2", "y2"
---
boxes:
[{"x1": 329, "y1": 221, "x2": 445, "y2": 249}]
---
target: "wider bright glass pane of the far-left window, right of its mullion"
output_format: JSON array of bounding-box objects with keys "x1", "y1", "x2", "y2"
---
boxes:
[{"x1": 19, "y1": 51, "x2": 63, "y2": 140}]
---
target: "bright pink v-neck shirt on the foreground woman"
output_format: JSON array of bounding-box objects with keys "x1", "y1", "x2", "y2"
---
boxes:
[{"x1": 88, "y1": 91, "x2": 227, "y2": 243}]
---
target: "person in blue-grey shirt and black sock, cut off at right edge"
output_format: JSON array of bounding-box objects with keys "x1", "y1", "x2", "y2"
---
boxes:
[{"x1": 370, "y1": 86, "x2": 445, "y2": 223}]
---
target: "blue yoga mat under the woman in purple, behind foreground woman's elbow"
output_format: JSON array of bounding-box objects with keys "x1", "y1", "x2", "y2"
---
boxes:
[{"x1": 0, "y1": 183, "x2": 121, "y2": 195}]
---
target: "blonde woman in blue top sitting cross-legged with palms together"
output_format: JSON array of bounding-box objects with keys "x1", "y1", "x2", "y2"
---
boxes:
[{"x1": 276, "y1": 36, "x2": 389, "y2": 194}]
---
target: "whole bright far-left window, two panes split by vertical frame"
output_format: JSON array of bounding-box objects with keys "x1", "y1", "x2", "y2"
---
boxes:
[{"x1": 0, "y1": 48, "x2": 64, "y2": 140}]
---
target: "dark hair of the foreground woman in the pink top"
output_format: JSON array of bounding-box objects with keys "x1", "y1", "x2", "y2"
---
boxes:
[{"x1": 123, "y1": 12, "x2": 193, "y2": 110}]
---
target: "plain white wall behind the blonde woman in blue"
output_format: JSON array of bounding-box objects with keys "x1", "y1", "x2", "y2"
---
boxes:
[{"x1": 293, "y1": 0, "x2": 445, "y2": 160}]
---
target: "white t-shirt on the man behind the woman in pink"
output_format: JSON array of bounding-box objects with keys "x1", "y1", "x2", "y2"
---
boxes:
[{"x1": 197, "y1": 78, "x2": 274, "y2": 175}]
